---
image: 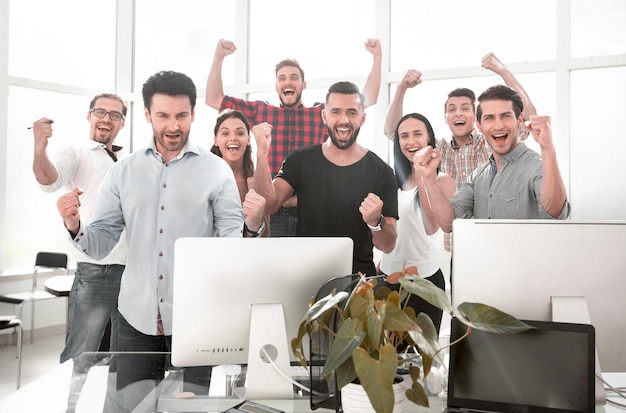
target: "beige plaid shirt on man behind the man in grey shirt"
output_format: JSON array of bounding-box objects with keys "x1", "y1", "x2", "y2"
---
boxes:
[{"x1": 437, "y1": 129, "x2": 491, "y2": 251}]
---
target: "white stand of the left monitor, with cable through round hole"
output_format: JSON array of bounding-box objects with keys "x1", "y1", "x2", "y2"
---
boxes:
[{"x1": 246, "y1": 304, "x2": 294, "y2": 400}]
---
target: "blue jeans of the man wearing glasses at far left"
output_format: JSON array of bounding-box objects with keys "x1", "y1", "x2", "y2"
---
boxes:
[{"x1": 61, "y1": 262, "x2": 124, "y2": 373}]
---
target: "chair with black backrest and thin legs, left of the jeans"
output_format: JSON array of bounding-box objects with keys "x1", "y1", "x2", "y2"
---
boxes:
[{"x1": 0, "y1": 252, "x2": 69, "y2": 343}]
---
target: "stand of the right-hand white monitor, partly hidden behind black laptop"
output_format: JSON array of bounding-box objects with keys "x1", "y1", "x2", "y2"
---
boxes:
[{"x1": 551, "y1": 296, "x2": 606, "y2": 404}]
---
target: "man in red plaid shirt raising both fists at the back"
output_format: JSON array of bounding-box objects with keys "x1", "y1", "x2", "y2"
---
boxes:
[{"x1": 206, "y1": 39, "x2": 382, "y2": 237}]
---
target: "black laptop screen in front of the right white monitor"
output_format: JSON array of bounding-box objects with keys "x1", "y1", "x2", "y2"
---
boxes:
[{"x1": 448, "y1": 319, "x2": 595, "y2": 413}]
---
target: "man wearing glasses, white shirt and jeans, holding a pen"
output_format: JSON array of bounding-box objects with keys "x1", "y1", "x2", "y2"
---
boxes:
[{"x1": 32, "y1": 93, "x2": 128, "y2": 411}]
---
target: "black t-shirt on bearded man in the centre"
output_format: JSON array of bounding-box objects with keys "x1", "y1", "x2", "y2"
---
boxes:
[{"x1": 277, "y1": 145, "x2": 398, "y2": 275}]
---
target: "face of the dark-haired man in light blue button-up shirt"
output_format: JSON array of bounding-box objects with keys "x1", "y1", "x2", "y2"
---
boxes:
[{"x1": 144, "y1": 93, "x2": 194, "y2": 162}]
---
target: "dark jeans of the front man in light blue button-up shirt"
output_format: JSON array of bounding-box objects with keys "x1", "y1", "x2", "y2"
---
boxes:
[{"x1": 117, "y1": 315, "x2": 211, "y2": 412}]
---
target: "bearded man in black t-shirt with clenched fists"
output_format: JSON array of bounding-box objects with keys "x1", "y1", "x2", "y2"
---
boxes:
[{"x1": 255, "y1": 82, "x2": 398, "y2": 275}]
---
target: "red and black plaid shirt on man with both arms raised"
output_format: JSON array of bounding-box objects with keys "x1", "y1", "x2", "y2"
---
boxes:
[{"x1": 220, "y1": 96, "x2": 327, "y2": 176}]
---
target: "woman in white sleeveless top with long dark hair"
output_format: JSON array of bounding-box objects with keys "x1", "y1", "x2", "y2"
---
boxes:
[{"x1": 380, "y1": 113, "x2": 455, "y2": 331}]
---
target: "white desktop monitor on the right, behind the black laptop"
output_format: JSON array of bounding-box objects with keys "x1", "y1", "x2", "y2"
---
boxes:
[{"x1": 451, "y1": 219, "x2": 626, "y2": 400}]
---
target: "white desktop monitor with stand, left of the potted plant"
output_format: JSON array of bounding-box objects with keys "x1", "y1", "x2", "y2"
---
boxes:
[{"x1": 172, "y1": 237, "x2": 353, "y2": 399}]
